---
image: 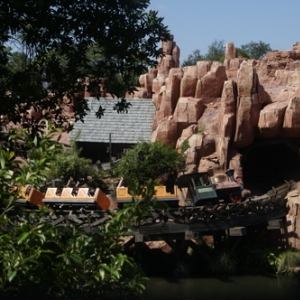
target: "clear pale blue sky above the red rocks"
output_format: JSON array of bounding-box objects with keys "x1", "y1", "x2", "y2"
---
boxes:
[{"x1": 150, "y1": 0, "x2": 300, "y2": 64}]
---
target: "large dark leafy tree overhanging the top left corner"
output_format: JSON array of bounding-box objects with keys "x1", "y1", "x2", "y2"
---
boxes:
[{"x1": 0, "y1": 0, "x2": 169, "y2": 128}]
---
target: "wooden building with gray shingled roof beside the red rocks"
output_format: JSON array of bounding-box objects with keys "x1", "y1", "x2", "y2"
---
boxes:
[{"x1": 70, "y1": 98, "x2": 155, "y2": 163}]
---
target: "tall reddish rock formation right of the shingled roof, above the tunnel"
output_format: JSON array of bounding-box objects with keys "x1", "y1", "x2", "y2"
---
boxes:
[{"x1": 138, "y1": 39, "x2": 300, "y2": 175}]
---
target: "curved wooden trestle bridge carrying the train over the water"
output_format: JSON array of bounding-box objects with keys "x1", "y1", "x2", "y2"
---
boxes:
[{"x1": 35, "y1": 181, "x2": 296, "y2": 243}]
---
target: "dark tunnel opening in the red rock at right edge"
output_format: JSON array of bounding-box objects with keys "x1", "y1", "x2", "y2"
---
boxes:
[{"x1": 241, "y1": 140, "x2": 300, "y2": 194}]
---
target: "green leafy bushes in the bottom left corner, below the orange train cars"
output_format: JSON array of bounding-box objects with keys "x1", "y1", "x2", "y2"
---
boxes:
[{"x1": 0, "y1": 207, "x2": 147, "y2": 299}]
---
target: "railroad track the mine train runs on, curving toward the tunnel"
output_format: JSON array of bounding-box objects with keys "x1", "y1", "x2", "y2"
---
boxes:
[{"x1": 24, "y1": 181, "x2": 296, "y2": 230}]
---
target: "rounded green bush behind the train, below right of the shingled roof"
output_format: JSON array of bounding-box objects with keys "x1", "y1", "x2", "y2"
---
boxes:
[{"x1": 117, "y1": 141, "x2": 184, "y2": 185}]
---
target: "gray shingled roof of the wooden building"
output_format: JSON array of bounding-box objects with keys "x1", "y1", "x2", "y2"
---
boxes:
[{"x1": 70, "y1": 98, "x2": 155, "y2": 144}]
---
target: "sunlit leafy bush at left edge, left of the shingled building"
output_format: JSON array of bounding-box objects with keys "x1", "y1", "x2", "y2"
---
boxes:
[{"x1": 0, "y1": 121, "x2": 61, "y2": 208}]
